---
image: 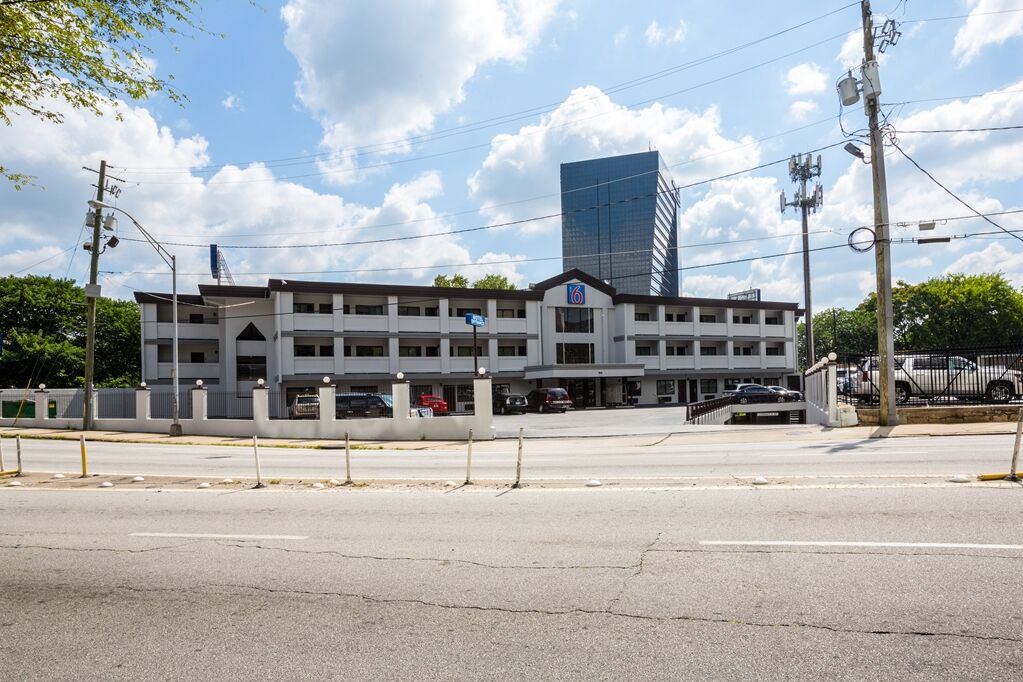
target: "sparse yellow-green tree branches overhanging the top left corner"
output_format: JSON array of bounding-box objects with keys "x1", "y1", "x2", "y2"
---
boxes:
[{"x1": 0, "y1": 0, "x2": 204, "y2": 188}]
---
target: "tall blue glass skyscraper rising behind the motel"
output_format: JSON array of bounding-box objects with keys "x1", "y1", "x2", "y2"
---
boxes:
[{"x1": 562, "y1": 151, "x2": 679, "y2": 297}]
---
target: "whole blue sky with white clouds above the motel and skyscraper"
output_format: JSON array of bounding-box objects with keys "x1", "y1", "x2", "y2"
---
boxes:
[{"x1": 0, "y1": 0, "x2": 1023, "y2": 309}]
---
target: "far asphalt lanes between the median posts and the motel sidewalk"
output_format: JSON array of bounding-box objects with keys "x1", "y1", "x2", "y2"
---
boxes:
[{"x1": 5, "y1": 428, "x2": 1014, "y2": 482}]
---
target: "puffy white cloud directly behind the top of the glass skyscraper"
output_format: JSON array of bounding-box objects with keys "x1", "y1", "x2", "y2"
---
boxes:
[{"x1": 469, "y1": 86, "x2": 760, "y2": 232}]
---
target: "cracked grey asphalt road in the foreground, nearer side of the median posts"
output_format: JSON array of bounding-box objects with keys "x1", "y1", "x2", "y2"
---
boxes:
[{"x1": 0, "y1": 487, "x2": 1023, "y2": 680}]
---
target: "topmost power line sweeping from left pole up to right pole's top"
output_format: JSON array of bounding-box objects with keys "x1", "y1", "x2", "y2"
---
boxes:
[{"x1": 121, "y1": 2, "x2": 858, "y2": 173}]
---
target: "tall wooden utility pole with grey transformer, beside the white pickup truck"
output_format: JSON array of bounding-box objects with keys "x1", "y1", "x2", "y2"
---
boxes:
[{"x1": 860, "y1": 0, "x2": 898, "y2": 426}]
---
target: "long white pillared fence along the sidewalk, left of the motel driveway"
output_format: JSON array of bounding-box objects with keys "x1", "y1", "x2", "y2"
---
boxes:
[{"x1": 0, "y1": 379, "x2": 496, "y2": 441}]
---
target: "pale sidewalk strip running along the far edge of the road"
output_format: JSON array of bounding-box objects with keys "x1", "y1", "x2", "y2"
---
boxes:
[{"x1": 0, "y1": 422, "x2": 1016, "y2": 450}]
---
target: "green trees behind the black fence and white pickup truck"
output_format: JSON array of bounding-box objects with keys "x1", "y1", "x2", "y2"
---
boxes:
[{"x1": 799, "y1": 273, "x2": 1023, "y2": 366}]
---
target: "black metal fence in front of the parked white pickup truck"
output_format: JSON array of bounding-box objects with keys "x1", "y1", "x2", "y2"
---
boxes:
[{"x1": 837, "y1": 345, "x2": 1023, "y2": 407}]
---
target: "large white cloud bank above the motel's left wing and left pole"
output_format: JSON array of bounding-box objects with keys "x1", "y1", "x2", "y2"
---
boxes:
[{"x1": 0, "y1": 103, "x2": 521, "y2": 297}]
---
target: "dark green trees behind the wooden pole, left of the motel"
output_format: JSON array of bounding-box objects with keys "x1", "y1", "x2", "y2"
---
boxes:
[{"x1": 0, "y1": 275, "x2": 139, "y2": 388}]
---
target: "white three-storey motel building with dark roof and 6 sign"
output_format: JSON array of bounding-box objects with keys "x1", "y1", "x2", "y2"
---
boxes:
[{"x1": 136, "y1": 271, "x2": 800, "y2": 408}]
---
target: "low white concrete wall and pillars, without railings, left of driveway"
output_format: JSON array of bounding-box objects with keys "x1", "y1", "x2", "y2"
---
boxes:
[{"x1": 0, "y1": 379, "x2": 496, "y2": 441}]
